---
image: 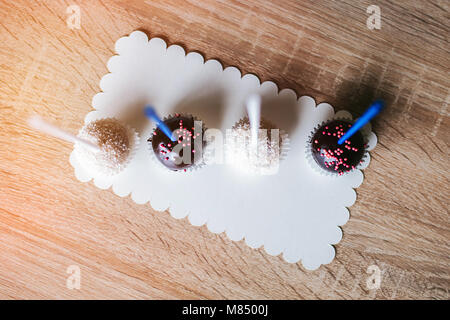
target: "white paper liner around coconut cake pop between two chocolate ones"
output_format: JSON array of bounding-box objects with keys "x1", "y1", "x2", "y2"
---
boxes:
[{"x1": 224, "y1": 117, "x2": 290, "y2": 175}]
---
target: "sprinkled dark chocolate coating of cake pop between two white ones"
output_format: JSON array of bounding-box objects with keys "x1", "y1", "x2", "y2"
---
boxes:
[{"x1": 148, "y1": 114, "x2": 204, "y2": 171}]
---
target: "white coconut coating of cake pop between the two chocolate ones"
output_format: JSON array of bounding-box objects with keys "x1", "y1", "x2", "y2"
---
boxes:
[{"x1": 226, "y1": 117, "x2": 282, "y2": 174}]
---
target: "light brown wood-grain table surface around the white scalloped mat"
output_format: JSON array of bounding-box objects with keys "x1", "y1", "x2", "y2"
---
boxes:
[{"x1": 0, "y1": 0, "x2": 450, "y2": 299}]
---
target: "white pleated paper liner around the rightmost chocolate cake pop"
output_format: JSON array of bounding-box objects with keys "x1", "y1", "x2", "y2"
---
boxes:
[{"x1": 305, "y1": 115, "x2": 369, "y2": 177}]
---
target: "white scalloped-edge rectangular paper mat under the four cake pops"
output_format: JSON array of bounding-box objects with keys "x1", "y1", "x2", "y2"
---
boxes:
[{"x1": 70, "y1": 31, "x2": 376, "y2": 270}]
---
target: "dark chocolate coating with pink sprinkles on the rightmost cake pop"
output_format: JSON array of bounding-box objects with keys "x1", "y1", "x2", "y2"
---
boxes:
[{"x1": 311, "y1": 120, "x2": 365, "y2": 175}]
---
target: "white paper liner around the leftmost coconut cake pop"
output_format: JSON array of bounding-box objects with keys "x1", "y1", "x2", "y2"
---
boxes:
[{"x1": 74, "y1": 117, "x2": 140, "y2": 177}]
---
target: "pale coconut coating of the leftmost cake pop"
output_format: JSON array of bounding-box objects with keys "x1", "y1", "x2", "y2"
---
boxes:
[{"x1": 78, "y1": 118, "x2": 130, "y2": 174}]
